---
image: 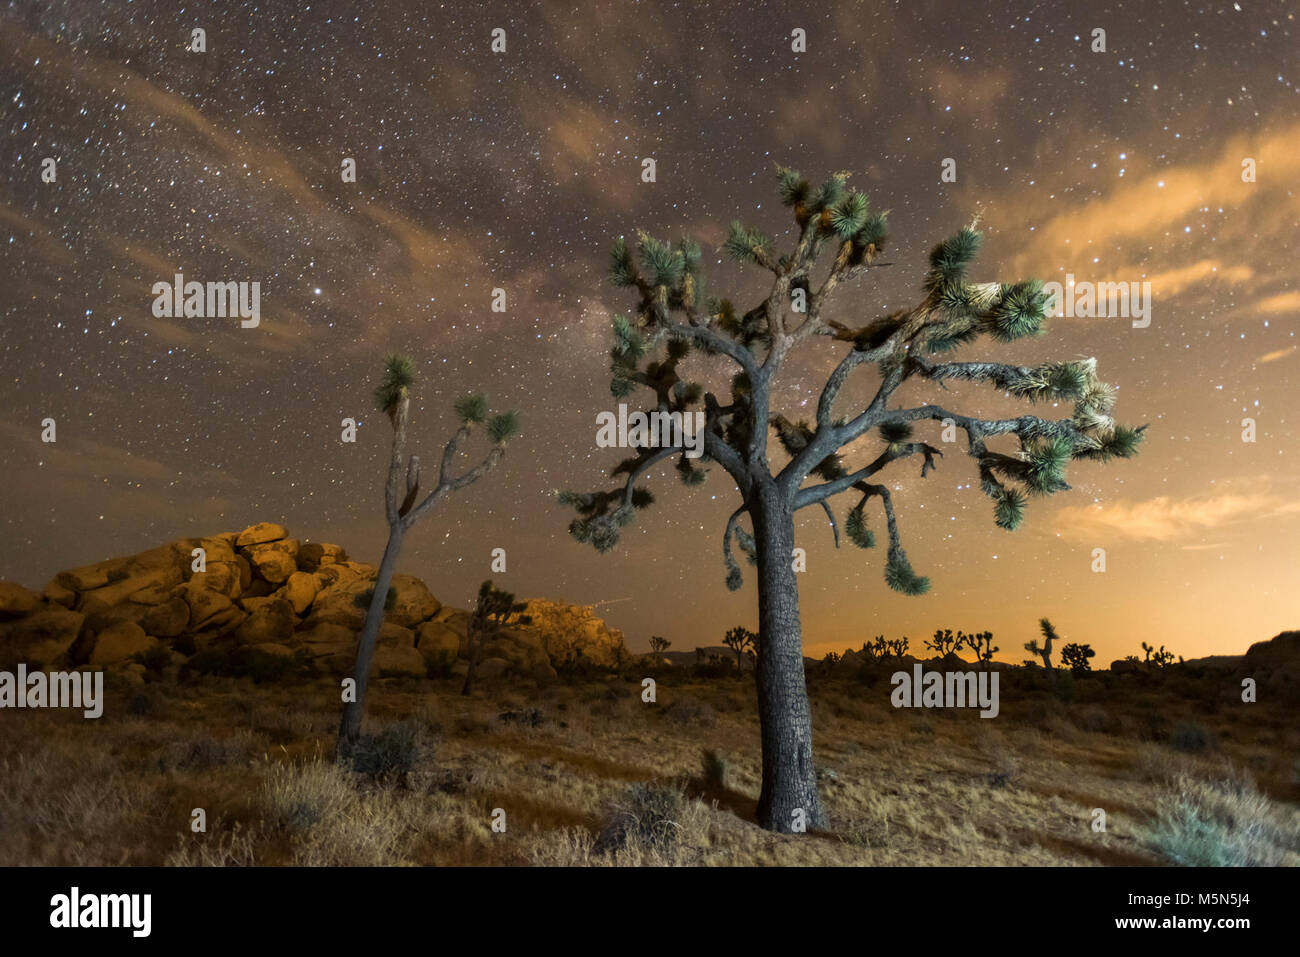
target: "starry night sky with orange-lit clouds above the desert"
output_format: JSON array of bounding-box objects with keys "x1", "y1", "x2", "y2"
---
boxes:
[{"x1": 0, "y1": 0, "x2": 1300, "y2": 666}]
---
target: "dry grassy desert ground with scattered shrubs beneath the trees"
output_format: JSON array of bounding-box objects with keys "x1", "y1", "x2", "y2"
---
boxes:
[{"x1": 0, "y1": 679, "x2": 1300, "y2": 866}]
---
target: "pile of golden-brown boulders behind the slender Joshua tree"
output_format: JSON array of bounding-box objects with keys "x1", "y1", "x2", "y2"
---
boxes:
[{"x1": 0, "y1": 521, "x2": 627, "y2": 680}]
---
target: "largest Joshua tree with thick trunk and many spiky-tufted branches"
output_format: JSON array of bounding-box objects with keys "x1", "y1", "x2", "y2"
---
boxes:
[{"x1": 560, "y1": 169, "x2": 1141, "y2": 831}]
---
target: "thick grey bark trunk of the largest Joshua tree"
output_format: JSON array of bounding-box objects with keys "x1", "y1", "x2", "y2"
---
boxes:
[{"x1": 750, "y1": 490, "x2": 827, "y2": 833}]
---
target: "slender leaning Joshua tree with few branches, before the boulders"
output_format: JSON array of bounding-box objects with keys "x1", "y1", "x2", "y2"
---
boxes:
[{"x1": 338, "y1": 355, "x2": 519, "y2": 745}]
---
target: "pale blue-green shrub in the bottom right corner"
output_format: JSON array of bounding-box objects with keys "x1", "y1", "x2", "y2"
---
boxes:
[{"x1": 1149, "y1": 775, "x2": 1300, "y2": 867}]
